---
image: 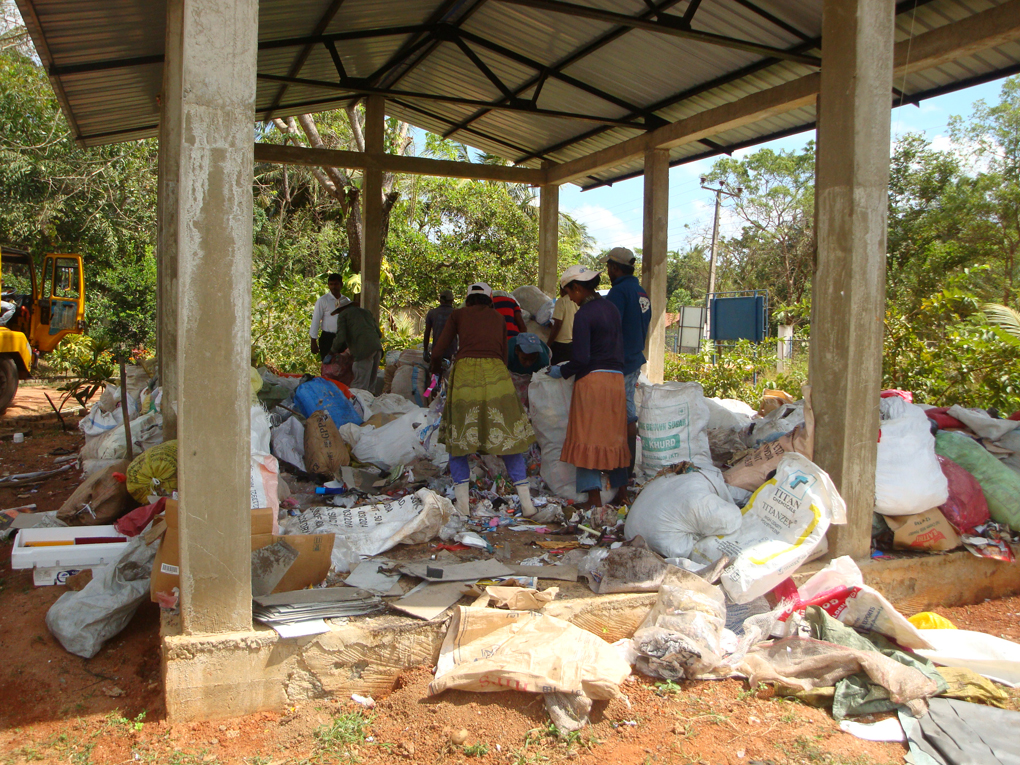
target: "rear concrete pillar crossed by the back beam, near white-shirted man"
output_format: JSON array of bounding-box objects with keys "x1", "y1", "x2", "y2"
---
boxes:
[{"x1": 361, "y1": 96, "x2": 386, "y2": 318}]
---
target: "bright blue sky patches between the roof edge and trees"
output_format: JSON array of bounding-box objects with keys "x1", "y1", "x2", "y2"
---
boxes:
[{"x1": 560, "y1": 81, "x2": 1002, "y2": 258}]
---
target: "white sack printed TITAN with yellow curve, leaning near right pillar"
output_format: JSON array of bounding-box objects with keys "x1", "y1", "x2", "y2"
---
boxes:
[{"x1": 692, "y1": 453, "x2": 847, "y2": 603}]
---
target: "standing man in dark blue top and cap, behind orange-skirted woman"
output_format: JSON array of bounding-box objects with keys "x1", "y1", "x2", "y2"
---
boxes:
[{"x1": 606, "y1": 247, "x2": 652, "y2": 475}]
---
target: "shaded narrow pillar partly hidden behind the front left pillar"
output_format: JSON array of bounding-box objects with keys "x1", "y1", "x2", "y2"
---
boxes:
[{"x1": 156, "y1": 2, "x2": 184, "y2": 442}]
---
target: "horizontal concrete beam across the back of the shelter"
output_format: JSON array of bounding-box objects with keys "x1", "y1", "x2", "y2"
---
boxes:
[{"x1": 255, "y1": 144, "x2": 546, "y2": 186}]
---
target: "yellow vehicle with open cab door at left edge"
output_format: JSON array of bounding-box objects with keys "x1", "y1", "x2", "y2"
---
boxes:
[{"x1": 0, "y1": 246, "x2": 85, "y2": 414}]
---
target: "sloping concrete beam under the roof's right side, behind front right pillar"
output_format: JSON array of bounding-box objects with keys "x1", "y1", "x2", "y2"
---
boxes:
[{"x1": 549, "y1": 0, "x2": 1020, "y2": 184}]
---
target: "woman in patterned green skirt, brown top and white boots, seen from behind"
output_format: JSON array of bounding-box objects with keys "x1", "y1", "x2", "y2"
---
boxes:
[{"x1": 431, "y1": 282, "x2": 536, "y2": 516}]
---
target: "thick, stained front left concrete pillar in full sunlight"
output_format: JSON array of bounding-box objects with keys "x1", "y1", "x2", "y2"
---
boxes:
[{"x1": 167, "y1": 0, "x2": 258, "y2": 634}]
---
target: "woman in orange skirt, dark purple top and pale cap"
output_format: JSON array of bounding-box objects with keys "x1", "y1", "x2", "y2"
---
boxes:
[{"x1": 549, "y1": 265, "x2": 630, "y2": 509}]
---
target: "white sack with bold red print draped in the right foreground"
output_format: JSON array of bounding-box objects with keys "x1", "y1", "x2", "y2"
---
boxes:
[{"x1": 773, "y1": 556, "x2": 929, "y2": 649}]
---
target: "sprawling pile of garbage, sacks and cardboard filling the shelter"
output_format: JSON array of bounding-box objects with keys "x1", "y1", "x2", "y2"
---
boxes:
[{"x1": 12, "y1": 297, "x2": 1020, "y2": 754}]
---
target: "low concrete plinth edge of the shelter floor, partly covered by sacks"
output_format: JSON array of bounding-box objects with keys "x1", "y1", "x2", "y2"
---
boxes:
[{"x1": 161, "y1": 553, "x2": 1020, "y2": 722}]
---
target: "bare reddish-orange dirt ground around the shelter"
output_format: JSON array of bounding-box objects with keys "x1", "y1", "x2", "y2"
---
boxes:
[{"x1": 0, "y1": 419, "x2": 1020, "y2": 765}]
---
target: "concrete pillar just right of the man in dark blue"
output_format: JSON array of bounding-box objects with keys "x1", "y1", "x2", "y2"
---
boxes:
[{"x1": 641, "y1": 149, "x2": 669, "y2": 384}]
